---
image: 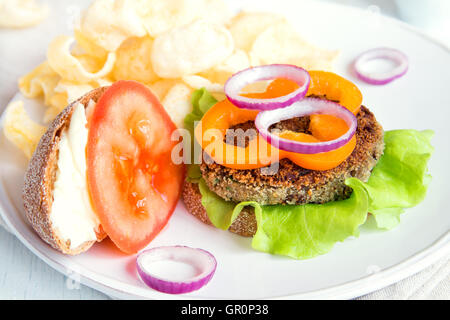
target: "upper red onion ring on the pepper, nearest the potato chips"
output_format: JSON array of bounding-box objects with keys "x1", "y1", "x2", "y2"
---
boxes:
[{"x1": 224, "y1": 64, "x2": 310, "y2": 110}]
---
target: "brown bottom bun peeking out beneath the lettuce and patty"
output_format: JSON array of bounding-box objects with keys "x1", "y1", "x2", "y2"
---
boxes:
[{"x1": 183, "y1": 181, "x2": 256, "y2": 237}]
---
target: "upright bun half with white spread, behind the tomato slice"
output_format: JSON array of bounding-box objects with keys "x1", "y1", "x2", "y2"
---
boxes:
[{"x1": 22, "y1": 87, "x2": 106, "y2": 255}]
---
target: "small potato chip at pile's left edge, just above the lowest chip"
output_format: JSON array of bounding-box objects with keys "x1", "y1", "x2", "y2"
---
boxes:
[{"x1": 19, "y1": 62, "x2": 61, "y2": 104}]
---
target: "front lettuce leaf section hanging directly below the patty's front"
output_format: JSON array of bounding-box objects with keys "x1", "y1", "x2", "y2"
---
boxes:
[{"x1": 252, "y1": 181, "x2": 369, "y2": 259}]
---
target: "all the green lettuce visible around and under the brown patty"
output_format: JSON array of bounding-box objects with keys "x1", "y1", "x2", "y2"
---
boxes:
[{"x1": 185, "y1": 89, "x2": 433, "y2": 259}]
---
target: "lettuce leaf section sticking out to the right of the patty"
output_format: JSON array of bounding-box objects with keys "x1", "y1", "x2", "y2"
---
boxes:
[{"x1": 350, "y1": 130, "x2": 433, "y2": 229}]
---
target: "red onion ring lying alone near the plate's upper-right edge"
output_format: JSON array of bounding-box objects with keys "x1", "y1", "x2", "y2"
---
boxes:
[{"x1": 353, "y1": 48, "x2": 409, "y2": 85}]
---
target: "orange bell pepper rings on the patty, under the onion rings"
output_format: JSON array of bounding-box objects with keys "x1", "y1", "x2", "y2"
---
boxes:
[{"x1": 195, "y1": 71, "x2": 362, "y2": 170}]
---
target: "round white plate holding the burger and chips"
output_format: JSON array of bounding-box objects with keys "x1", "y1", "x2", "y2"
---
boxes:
[{"x1": 0, "y1": 0, "x2": 450, "y2": 299}]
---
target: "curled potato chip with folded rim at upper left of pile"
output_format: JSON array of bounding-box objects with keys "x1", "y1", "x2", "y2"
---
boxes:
[{"x1": 47, "y1": 36, "x2": 116, "y2": 82}]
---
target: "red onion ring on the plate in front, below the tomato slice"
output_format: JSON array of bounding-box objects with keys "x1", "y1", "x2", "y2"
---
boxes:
[{"x1": 136, "y1": 246, "x2": 217, "y2": 294}]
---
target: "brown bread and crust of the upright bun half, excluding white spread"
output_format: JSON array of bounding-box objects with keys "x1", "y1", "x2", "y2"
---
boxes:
[{"x1": 22, "y1": 87, "x2": 107, "y2": 255}]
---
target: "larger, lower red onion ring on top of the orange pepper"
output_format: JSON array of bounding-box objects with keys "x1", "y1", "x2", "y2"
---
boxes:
[{"x1": 255, "y1": 98, "x2": 357, "y2": 154}]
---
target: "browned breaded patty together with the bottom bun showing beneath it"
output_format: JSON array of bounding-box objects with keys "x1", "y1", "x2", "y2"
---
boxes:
[{"x1": 183, "y1": 106, "x2": 384, "y2": 236}]
